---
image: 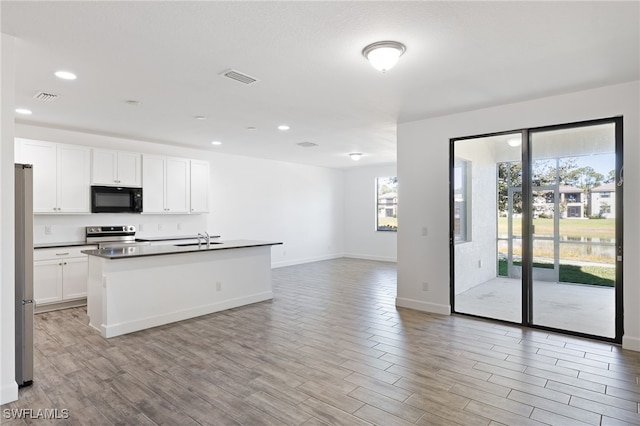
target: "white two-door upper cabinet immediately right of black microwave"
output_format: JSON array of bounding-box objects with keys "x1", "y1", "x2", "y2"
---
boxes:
[{"x1": 142, "y1": 155, "x2": 190, "y2": 213}]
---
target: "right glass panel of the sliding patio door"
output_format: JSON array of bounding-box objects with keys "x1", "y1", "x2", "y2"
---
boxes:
[{"x1": 529, "y1": 122, "x2": 619, "y2": 339}]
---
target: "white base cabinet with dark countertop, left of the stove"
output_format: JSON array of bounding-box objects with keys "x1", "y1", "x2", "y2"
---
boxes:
[{"x1": 33, "y1": 246, "x2": 96, "y2": 312}]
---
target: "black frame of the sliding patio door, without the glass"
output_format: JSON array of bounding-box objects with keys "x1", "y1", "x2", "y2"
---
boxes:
[{"x1": 449, "y1": 116, "x2": 624, "y2": 343}]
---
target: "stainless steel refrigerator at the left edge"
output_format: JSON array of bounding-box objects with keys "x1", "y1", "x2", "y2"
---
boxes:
[{"x1": 15, "y1": 164, "x2": 34, "y2": 386}]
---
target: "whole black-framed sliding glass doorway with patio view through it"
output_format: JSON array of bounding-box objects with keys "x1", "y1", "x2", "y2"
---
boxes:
[{"x1": 451, "y1": 118, "x2": 623, "y2": 341}]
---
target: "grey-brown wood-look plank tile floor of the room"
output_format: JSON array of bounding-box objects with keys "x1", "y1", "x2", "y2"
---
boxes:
[{"x1": 2, "y1": 259, "x2": 640, "y2": 426}]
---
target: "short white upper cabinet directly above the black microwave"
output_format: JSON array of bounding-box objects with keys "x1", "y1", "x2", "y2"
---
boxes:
[{"x1": 91, "y1": 149, "x2": 142, "y2": 188}]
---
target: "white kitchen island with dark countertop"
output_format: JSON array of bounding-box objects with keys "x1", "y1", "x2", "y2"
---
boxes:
[{"x1": 83, "y1": 240, "x2": 282, "y2": 338}]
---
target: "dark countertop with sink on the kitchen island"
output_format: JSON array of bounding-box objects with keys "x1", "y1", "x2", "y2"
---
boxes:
[{"x1": 82, "y1": 240, "x2": 282, "y2": 260}]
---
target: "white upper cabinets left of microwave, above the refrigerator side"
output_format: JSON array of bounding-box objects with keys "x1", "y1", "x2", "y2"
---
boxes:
[{"x1": 17, "y1": 139, "x2": 91, "y2": 213}]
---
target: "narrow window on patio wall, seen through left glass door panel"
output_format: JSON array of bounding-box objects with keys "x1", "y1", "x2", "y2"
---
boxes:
[{"x1": 453, "y1": 159, "x2": 471, "y2": 243}]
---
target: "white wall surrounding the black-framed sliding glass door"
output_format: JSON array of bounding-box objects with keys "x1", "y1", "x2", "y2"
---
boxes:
[{"x1": 396, "y1": 81, "x2": 640, "y2": 350}]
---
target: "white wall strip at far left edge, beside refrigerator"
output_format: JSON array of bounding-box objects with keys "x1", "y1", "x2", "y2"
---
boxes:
[{"x1": 0, "y1": 34, "x2": 18, "y2": 404}]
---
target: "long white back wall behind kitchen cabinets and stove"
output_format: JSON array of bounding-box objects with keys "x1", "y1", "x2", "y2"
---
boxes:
[{"x1": 16, "y1": 124, "x2": 344, "y2": 267}]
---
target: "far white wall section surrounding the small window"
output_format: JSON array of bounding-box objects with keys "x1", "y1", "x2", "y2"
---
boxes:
[{"x1": 344, "y1": 164, "x2": 396, "y2": 262}]
